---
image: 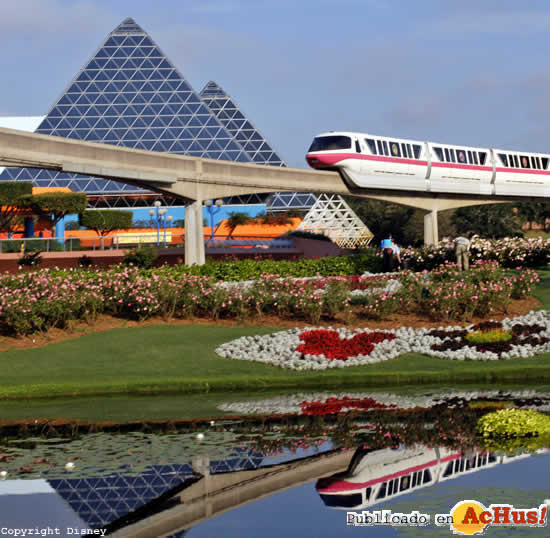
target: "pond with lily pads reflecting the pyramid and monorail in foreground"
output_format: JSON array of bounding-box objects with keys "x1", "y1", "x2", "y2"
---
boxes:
[{"x1": 0, "y1": 387, "x2": 550, "y2": 538}]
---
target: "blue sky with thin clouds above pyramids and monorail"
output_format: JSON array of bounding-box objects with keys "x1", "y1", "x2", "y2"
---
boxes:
[{"x1": 0, "y1": 0, "x2": 550, "y2": 167}]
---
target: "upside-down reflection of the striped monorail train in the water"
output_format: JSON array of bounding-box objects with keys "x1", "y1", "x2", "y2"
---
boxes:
[{"x1": 316, "y1": 446, "x2": 548, "y2": 510}]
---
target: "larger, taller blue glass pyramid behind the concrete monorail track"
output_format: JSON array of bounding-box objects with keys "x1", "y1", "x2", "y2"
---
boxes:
[{"x1": 0, "y1": 18, "x2": 315, "y2": 207}]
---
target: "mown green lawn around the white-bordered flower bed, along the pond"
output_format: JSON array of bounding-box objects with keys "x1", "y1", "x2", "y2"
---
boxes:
[{"x1": 0, "y1": 264, "x2": 550, "y2": 399}]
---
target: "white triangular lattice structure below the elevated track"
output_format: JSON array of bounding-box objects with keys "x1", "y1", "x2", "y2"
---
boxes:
[{"x1": 298, "y1": 194, "x2": 373, "y2": 248}]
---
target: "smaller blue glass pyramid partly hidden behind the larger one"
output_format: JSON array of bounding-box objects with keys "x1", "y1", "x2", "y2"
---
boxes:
[{"x1": 200, "y1": 80, "x2": 315, "y2": 211}]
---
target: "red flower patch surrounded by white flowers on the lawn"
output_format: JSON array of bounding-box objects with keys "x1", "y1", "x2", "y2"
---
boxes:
[{"x1": 296, "y1": 329, "x2": 395, "y2": 361}]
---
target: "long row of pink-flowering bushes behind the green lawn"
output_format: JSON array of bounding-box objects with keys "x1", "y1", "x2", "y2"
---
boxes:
[{"x1": 0, "y1": 264, "x2": 538, "y2": 336}]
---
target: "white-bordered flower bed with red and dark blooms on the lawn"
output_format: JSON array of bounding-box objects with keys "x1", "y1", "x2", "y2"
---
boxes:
[{"x1": 216, "y1": 310, "x2": 550, "y2": 370}]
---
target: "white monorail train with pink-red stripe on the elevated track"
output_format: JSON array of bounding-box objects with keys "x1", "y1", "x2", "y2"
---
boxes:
[{"x1": 306, "y1": 132, "x2": 550, "y2": 197}]
